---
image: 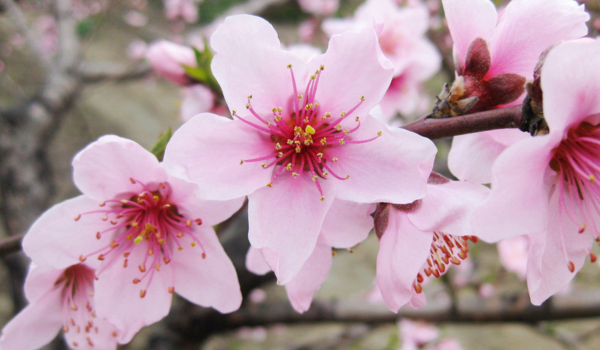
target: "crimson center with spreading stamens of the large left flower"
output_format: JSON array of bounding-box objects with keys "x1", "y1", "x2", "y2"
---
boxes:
[{"x1": 75, "y1": 179, "x2": 206, "y2": 298}]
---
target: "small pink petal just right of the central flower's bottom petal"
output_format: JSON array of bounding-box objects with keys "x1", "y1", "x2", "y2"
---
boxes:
[{"x1": 285, "y1": 244, "x2": 332, "y2": 313}]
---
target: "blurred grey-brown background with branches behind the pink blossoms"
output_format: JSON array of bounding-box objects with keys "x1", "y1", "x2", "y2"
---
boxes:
[{"x1": 0, "y1": 0, "x2": 600, "y2": 350}]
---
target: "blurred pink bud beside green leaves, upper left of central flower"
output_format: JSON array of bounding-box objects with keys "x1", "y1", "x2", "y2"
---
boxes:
[{"x1": 146, "y1": 40, "x2": 196, "y2": 85}]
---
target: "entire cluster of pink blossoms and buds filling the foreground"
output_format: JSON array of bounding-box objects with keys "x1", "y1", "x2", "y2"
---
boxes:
[{"x1": 0, "y1": 0, "x2": 600, "y2": 350}]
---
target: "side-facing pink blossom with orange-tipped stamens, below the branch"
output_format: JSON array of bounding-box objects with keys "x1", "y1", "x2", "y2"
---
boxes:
[{"x1": 375, "y1": 173, "x2": 487, "y2": 312}]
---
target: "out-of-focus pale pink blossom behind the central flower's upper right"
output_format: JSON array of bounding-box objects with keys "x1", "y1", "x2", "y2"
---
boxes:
[{"x1": 323, "y1": 0, "x2": 441, "y2": 121}]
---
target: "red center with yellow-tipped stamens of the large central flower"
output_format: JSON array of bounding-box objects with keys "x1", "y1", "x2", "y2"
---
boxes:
[{"x1": 232, "y1": 65, "x2": 382, "y2": 201}]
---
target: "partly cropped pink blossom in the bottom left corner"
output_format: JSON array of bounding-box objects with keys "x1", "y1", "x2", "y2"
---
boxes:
[{"x1": 0, "y1": 264, "x2": 123, "y2": 350}]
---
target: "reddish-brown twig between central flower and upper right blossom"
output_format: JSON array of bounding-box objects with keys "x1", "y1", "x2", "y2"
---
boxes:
[{"x1": 403, "y1": 105, "x2": 522, "y2": 140}]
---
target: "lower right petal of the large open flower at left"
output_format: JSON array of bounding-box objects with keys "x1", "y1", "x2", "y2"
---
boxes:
[{"x1": 172, "y1": 226, "x2": 242, "y2": 313}]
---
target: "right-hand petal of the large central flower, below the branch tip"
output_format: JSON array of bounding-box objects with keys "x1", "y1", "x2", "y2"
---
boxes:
[{"x1": 330, "y1": 117, "x2": 436, "y2": 203}]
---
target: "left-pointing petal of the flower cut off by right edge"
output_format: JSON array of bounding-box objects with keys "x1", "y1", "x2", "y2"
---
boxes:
[{"x1": 472, "y1": 135, "x2": 560, "y2": 242}]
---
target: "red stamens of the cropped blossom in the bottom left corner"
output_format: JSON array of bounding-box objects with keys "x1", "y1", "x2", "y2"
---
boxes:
[{"x1": 55, "y1": 264, "x2": 117, "y2": 347}]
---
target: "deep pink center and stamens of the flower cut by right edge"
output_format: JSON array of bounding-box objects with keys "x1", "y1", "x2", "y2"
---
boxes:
[{"x1": 550, "y1": 122, "x2": 600, "y2": 272}]
